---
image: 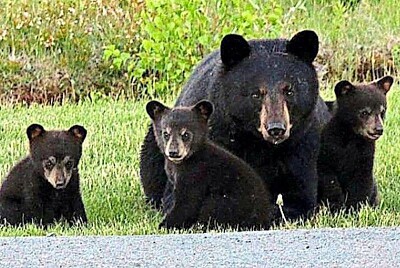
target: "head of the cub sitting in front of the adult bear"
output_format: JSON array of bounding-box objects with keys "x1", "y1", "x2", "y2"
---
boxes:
[{"x1": 146, "y1": 100, "x2": 214, "y2": 164}]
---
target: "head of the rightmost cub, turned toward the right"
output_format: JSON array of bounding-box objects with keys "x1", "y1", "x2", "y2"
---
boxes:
[{"x1": 335, "y1": 76, "x2": 393, "y2": 141}]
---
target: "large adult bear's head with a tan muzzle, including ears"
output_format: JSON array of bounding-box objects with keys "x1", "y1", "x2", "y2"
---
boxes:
[{"x1": 215, "y1": 31, "x2": 319, "y2": 144}]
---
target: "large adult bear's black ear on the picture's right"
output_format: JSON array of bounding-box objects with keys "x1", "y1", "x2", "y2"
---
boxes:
[{"x1": 286, "y1": 30, "x2": 319, "y2": 63}]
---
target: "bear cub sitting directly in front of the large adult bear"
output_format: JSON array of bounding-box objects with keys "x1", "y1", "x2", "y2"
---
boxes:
[{"x1": 146, "y1": 100, "x2": 272, "y2": 229}]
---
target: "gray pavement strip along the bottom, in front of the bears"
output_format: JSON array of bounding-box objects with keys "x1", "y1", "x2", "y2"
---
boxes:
[{"x1": 0, "y1": 228, "x2": 400, "y2": 268}]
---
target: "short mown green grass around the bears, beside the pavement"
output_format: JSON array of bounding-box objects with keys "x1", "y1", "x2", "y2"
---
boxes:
[{"x1": 0, "y1": 87, "x2": 400, "y2": 236}]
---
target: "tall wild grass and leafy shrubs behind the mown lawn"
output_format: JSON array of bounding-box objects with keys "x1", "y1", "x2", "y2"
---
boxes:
[{"x1": 0, "y1": 0, "x2": 400, "y2": 103}]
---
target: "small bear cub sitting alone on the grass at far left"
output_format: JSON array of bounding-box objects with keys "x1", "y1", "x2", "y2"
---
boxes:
[{"x1": 0, "y1": 124, "x2": 87, "y2": 226}]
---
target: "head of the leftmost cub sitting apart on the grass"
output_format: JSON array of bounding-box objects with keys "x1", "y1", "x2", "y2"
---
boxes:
[{"x1": 26, "y1": 124, "x2": 86, "y2": 189}]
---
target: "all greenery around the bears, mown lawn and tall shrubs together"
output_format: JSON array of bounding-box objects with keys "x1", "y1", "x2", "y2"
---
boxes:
[{"x1": 0, "y1": 0, "x2": 400, "y2": 235}]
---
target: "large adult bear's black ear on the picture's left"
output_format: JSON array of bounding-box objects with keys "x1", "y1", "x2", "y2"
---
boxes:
[{"x1": 220, "y1": 34, "x2": 250, "y2": 68}]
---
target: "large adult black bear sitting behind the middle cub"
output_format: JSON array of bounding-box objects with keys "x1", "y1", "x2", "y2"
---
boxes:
[{"x1": 140, "y1": 30, "x2": 331, "y2": 219}]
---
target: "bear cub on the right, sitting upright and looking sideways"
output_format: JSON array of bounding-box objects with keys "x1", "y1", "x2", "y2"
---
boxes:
[{"x1": 318, "y1": 76, "x2": 393, "y2": 212}]
